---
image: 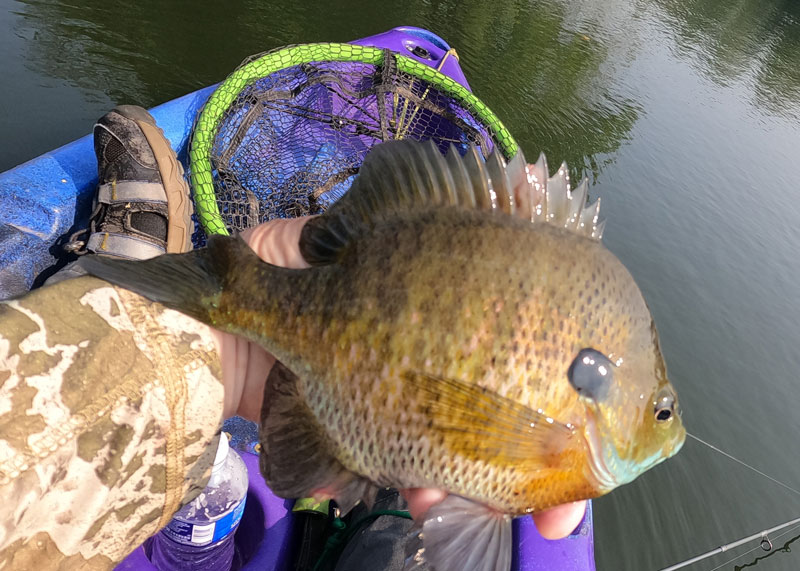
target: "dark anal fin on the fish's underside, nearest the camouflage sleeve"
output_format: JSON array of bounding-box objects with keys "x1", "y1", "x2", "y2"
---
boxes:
[{"x1": 259, "y1": 362, "x2": 377, "y2": 513}]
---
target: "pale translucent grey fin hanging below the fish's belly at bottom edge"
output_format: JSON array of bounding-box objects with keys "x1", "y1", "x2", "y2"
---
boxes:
[{"x1": 404, "y1": 495, "x2": 512, "y2": 571}]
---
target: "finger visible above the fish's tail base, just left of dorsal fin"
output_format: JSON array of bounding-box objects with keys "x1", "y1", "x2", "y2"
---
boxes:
[{"x1": 241, "y1": 216, "x2": 310, "y2": 268}]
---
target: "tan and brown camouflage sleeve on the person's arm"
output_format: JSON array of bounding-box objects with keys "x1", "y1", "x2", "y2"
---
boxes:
[{"x1": 0, "y1": 277, "x2": 224, "y2": 570}]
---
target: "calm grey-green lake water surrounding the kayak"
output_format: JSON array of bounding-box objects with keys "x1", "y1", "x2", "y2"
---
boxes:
[{"x1": 0, "y1": 0, "x2": 800, "y2": 571}]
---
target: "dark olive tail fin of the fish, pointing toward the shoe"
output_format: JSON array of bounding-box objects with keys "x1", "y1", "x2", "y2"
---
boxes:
[{"x1": 80, "y1": 236, "x2": 258, "y2": 321}]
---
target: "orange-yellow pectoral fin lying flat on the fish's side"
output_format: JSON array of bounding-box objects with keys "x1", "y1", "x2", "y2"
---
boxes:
[{"x1": 405, "y1": 371, "x2": 584, "y2": 469}]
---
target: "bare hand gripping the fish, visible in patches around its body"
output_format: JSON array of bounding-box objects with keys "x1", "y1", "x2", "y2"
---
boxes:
[{"x1": 215, "y1": 218, "x2": 586, "y2": 539}]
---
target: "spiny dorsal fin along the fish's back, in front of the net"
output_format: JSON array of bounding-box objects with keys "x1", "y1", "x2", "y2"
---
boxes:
[{"x1": 300, "y1": 140, "x2": 603, "y2": 265}]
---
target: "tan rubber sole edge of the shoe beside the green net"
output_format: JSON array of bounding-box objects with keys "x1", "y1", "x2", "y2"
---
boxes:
[{"x1": 114, "y1": 105, "x2": 194, "y2": 254}]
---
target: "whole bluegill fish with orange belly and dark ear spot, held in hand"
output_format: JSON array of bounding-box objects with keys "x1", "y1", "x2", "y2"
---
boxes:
[{"x1": 85, "y1": 141, "x2": 685, "y2": 571}]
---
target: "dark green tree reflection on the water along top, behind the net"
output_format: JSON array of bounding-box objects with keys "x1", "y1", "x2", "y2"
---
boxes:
[{"x1": 7, "y1": 0, "x2": 637, "y2": 183}]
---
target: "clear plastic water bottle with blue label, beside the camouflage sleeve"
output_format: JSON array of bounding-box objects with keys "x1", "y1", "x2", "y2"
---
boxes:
[{"x1": 150, "y1": 432, "x2": 247, "y2": 571}]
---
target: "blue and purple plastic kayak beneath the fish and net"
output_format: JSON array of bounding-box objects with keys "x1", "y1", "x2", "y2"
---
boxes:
[{"x1": 0, "y1": 27, "x2": 595, "y2": 571}]
